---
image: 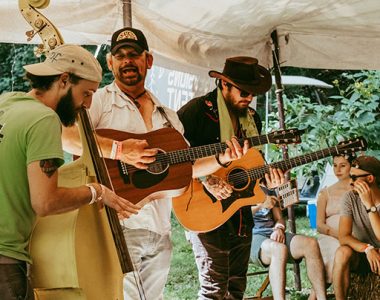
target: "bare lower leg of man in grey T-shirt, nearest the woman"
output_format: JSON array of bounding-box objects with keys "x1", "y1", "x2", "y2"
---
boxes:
[{"x1": 333, "y1": 246, "x2": 354, "y2": 300}]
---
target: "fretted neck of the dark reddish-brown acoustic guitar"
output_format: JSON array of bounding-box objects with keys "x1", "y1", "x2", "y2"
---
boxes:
[{"x1": 166, "y1": 135, "x2": 270, "y2": 164}]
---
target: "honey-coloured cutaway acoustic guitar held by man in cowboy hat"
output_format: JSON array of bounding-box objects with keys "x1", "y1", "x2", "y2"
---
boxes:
[{"x1": 173, "y1": 138, "x2": 367, "y2": 232}]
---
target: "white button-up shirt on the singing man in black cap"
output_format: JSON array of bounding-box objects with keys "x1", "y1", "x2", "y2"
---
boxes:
[{"x1": 89, "y1": 82, "x2": 184, "y2": 234}]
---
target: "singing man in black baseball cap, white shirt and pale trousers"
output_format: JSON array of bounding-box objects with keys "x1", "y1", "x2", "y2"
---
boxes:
[{"x1": 63, "y1": 27, "x2": 247, "y2": 300}]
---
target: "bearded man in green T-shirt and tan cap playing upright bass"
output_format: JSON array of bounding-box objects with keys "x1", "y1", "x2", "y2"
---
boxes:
[{"x1": 0, "y1": 44, "x2": 139, "y2": 300}]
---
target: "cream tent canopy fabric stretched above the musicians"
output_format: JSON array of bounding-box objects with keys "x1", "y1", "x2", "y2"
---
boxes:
[{"x1": 0, "y1": 0, "x2": 380, "y2": 70}]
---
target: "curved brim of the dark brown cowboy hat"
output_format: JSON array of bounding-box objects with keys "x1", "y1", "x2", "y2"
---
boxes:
[{"x1": 208, "y1": 65, "x2": 272, "y2": 95}]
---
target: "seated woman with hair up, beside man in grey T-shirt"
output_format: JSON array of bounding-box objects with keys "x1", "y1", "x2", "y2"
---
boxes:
[{"x1": 317, "y1": 156, "x2": 354, "y2": 285}]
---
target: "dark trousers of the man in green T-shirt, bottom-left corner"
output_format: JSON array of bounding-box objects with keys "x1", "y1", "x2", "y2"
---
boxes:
[{"x1": 0, "y1": 263, "x2": 34, "y2": 300}]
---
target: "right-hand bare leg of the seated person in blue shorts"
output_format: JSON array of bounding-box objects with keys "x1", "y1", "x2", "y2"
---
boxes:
[{"x1": 290, "y1": 235, "x2": 326, "y2": 300}]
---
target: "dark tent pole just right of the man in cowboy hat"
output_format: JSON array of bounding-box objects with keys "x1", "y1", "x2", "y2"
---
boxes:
[{"x1": 271, "y1": 30, "x2": 301, "y2": 291}]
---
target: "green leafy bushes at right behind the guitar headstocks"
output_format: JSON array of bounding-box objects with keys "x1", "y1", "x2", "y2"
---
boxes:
[{"x1": 269, "y1": 71, "x2": 380, "y2": 175}]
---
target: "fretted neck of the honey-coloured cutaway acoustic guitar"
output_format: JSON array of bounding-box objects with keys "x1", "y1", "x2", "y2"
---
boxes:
[{"x1": 248, "y1": 147, "x2": 339, "y2": 180}]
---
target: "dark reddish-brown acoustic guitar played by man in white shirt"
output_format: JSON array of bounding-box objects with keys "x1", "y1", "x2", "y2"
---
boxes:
[{"x1": 96, "y1": 128, "x2": 301, "y2": 204}]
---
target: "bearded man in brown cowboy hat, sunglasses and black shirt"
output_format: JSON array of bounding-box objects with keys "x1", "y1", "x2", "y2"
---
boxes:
[{"x1": 178, "y1": 56, "x2": 272, "y2": 299}]
